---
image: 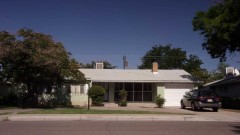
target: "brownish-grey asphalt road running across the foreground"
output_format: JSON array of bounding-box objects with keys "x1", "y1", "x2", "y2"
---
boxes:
[{"x1": 0, "y1": 121, "x2": 240, "y2": 135}]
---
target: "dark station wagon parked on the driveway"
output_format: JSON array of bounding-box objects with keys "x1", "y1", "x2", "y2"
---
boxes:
[{"x1": 180, "y1": 90, "x2": 222, "y2": 112}]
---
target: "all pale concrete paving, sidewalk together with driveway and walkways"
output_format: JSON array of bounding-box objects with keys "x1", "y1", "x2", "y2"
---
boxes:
[{"x1": 0, "y1": 104, "x2": 240, "y2": 122}]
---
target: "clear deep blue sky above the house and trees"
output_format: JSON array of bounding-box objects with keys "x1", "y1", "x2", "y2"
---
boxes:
[{"x1": 0, "y1": 0, "x2": 240, "y2": 70}]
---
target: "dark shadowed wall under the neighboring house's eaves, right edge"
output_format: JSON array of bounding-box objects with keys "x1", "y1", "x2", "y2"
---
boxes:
[{"x1": 213, "y1": 83, "x2": 240, "y2": 98}]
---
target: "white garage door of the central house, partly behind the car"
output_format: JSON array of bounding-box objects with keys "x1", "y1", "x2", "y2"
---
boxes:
[{"x1": 164, "y1": 84, "x2": 193, "y2": 106}]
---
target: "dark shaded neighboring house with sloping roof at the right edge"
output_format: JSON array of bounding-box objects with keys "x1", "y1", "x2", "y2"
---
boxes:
[{"x1": 204, "y1": 75, "x2": 240, "y2": 98}]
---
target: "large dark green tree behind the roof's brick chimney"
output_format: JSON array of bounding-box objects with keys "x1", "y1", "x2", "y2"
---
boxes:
[{"x1": 139, "y1": 44, "x2": 208, "y2": 81}]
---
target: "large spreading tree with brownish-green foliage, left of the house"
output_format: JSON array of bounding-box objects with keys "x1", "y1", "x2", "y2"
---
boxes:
[{"x1": 0, "y1": 28, "x2": 86, "y2": 106}]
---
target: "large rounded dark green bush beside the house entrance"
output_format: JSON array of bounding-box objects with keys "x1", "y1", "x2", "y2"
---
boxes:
[{"x1": 88, "y1": 86, "x2": 105, "y2": 106}]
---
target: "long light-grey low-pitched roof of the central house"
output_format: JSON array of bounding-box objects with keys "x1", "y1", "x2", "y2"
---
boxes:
[{"x1": 79, "y1": 69, "x2": 198, "y2": 83}]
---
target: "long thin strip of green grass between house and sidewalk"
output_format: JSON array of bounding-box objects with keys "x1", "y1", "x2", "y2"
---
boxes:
[{"x1": 18, "y1": 108, "x2": 193, "y2": 115}]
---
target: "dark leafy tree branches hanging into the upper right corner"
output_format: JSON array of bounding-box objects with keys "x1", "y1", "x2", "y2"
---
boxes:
[{"x1": 192, "y1": 0, "x2": 240, "y2": 61}]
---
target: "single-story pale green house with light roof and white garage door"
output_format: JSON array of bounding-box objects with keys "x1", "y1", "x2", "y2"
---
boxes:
[{"x1": 71, "y1": 63, "x2": 199, "y2": 106}]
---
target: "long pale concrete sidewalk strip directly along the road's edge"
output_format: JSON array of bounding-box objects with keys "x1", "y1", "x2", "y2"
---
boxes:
[{"x1": 4, "y1": 114, "x2": 240, "y2": 122}]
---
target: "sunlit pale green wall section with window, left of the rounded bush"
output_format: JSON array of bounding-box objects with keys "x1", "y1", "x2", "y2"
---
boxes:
[{"x1": 71, "y1": 84, "x2": 89, "y2": 107}]
